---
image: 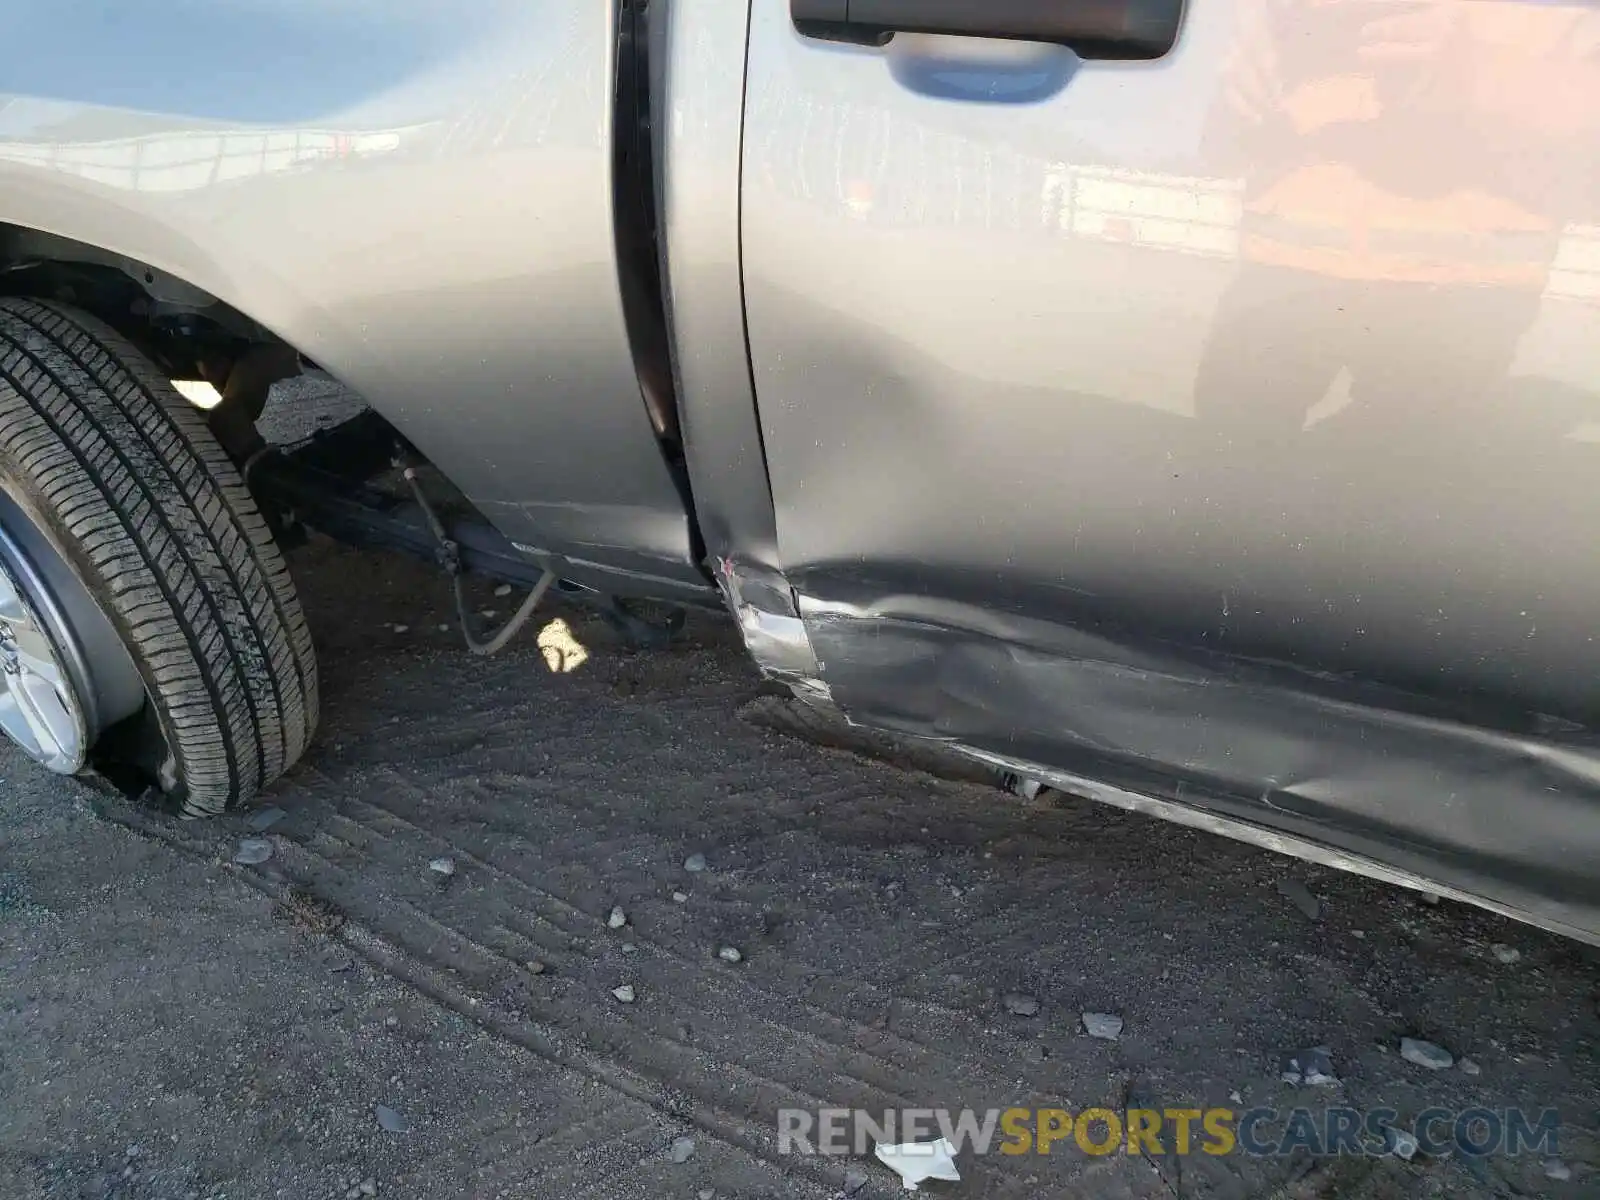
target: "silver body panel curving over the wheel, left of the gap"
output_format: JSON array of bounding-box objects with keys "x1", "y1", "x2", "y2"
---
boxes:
[{"x1": 0, "y1": 0, "x2": 704, "y2": 592}]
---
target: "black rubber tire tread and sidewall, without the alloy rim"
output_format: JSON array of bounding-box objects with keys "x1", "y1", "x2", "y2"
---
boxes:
[{"x1": 0, "y1": 299, "x2": 317, "y2": 816}]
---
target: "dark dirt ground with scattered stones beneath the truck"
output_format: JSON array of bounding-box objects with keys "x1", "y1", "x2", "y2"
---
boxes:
[{"x1": 0, "y1": 425, "x2": 1600, "y2": 1200}]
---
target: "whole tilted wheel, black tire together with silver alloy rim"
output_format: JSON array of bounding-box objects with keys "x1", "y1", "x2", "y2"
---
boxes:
[{"x1": 0, "y1": 299, "x2": 317, "y2": 816}]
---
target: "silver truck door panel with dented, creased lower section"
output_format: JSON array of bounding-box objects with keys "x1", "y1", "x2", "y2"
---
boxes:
[{"x1": 742, "y1": 0, "x2": 1600, "y2": 940}]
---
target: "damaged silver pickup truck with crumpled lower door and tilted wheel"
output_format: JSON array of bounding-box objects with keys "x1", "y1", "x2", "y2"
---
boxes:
[{"x1": 0, "y1": 0, "x2": 1600, "y2": 941}]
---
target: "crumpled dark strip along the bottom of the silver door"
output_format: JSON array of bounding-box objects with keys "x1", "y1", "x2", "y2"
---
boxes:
[{"x1": 800, "y1": 574, "x2": 1600, "y2": 941}]
